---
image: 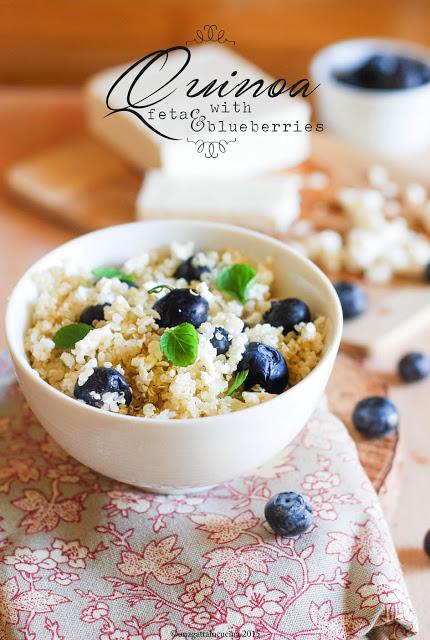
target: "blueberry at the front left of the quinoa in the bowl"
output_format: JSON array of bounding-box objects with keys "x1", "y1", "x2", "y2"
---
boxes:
[{"x1": 73, "y1": 367, "x2": 131, "y2": 408}]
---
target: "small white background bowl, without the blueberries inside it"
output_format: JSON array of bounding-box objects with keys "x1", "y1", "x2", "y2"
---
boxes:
[{"x1": 311, "y1": 38, "x2": 430, "y2": 159}]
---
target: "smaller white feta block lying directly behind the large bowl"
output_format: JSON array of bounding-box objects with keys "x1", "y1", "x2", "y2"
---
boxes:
[{"x1": 136, "y1": 169, "x2": 301, "y2": 233}]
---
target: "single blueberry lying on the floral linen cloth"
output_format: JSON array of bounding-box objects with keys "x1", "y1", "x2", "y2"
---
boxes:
[{"x1": 264, "y1": 491, "x2": 312, "y2": 536}]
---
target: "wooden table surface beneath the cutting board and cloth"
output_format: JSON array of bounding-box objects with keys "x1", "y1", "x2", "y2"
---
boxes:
[{"x1": 0, "y1": 88, "x2": 430, "y2": 640}]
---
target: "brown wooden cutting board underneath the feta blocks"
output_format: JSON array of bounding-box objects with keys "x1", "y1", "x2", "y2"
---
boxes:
[{"x1": 5, "y1": 134, "x2": 430, "y2": 233}]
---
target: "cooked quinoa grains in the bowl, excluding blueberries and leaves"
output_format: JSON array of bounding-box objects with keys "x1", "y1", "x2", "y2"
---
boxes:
[{"x1": 25, "y1": 243, "x2": 326, "y2": 418}]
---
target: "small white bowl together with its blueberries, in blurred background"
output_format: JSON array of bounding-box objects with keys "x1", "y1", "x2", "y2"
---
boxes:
[{"x1": 311, "y1": 38, "x2": 430, "y2": 160}]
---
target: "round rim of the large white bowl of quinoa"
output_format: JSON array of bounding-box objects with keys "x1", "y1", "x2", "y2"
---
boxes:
[{"x1": 5, "y1": 219, "x2": 343, "y2": 428}]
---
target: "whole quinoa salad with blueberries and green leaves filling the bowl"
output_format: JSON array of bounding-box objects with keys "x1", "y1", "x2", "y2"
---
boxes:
[{"x1": 24, "y1": 241, "x2": 327, "y2": 419}]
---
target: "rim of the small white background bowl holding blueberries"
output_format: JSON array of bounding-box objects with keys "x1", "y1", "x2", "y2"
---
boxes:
[{"x1": 309, "y1": 37, "x2": 430, "y2": 99}]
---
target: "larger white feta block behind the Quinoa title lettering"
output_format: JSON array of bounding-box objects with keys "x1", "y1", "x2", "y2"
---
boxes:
[{"x1": 85, "y1": 44, "x2": 311, "y2": 178}]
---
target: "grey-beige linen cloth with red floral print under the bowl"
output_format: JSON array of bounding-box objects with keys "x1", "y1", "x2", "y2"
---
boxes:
[{"x1": 0, "y1": 359, "x2": 417, "y2": 640}]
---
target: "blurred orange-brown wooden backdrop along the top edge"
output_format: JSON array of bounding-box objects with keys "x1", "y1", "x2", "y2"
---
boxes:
[{"x1": 0, "y1": 0, "x2": 430, "y2": 85}]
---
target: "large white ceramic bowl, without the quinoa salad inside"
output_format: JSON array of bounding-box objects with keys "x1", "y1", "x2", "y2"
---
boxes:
[{"x1": 6, "y1": 221, "x2": 342, "y2": 493}]
